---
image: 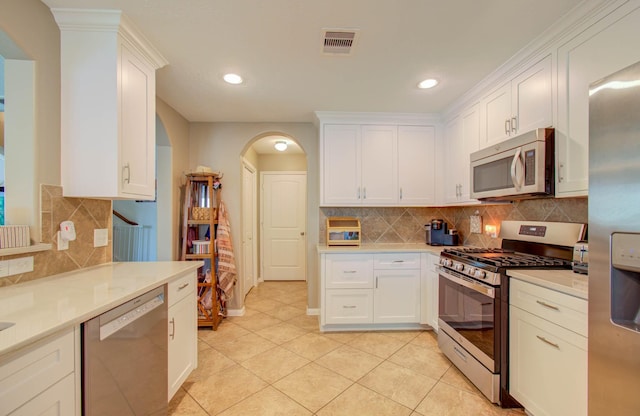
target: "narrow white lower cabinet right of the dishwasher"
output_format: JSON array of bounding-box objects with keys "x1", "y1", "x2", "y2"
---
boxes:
[{"x1": 167, "y1": 272, "x2": 198, "y2": 400}]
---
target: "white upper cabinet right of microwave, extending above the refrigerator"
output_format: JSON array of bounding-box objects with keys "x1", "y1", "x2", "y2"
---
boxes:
[{"x1": 555, "y1": 2, "x2": 640, "y2": 197}]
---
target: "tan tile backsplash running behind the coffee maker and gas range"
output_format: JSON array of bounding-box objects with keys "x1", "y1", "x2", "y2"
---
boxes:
[{"x1": 320, "y1": 198, "x2": 588, "y2": 247}]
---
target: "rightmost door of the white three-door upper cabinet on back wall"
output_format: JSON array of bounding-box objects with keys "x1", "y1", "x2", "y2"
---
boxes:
[{"x1": 398, "y1": 126, "x2": 436, "y2": 206}]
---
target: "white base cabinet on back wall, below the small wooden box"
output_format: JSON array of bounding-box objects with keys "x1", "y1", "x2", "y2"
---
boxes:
[{"x1": 320, "y1": 253, "x2": 421, "y2": 329}]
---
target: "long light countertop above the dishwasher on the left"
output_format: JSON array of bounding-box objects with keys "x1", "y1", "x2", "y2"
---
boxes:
[{"x1": 0, "y1": 261, "x2": 202, "y2": 358}]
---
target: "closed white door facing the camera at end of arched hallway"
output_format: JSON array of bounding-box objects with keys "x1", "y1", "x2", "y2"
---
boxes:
[{"x1": 260, "y1": 172, "x2": 307, "y2": 280}]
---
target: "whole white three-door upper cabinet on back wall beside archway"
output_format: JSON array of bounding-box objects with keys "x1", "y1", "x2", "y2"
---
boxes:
[{"x1": 320, "y1": 116, "x2": 436, "y2": 206}]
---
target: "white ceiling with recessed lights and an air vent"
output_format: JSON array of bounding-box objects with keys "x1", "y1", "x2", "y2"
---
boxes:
[{"x1": 43, "y1": 0, "x2": 580, "y2": 122}]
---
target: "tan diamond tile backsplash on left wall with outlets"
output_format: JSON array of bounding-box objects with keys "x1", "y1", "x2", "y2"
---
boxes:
[{"x1": 0, "y1": 185, "x2": 113, "y2": 286}]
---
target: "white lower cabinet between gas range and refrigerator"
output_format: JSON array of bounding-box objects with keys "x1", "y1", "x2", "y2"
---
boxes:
[{"x1": 509, "y1": 278, "x2": 587, "y2": 416}]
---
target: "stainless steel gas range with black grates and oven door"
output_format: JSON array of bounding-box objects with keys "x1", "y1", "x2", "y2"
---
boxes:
[{"x1": 438, "y1": 221, "x2": 586, "y2": 407}]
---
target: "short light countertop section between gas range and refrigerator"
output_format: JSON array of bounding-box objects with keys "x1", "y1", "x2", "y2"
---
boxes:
[{"x1": 507, "y1": 269, "x2": 589, "y2": 300}]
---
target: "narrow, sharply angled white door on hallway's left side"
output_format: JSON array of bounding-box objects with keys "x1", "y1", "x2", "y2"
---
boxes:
[{"x1": 242, "y1": 162, "x2": 258, "y2": 295}]
